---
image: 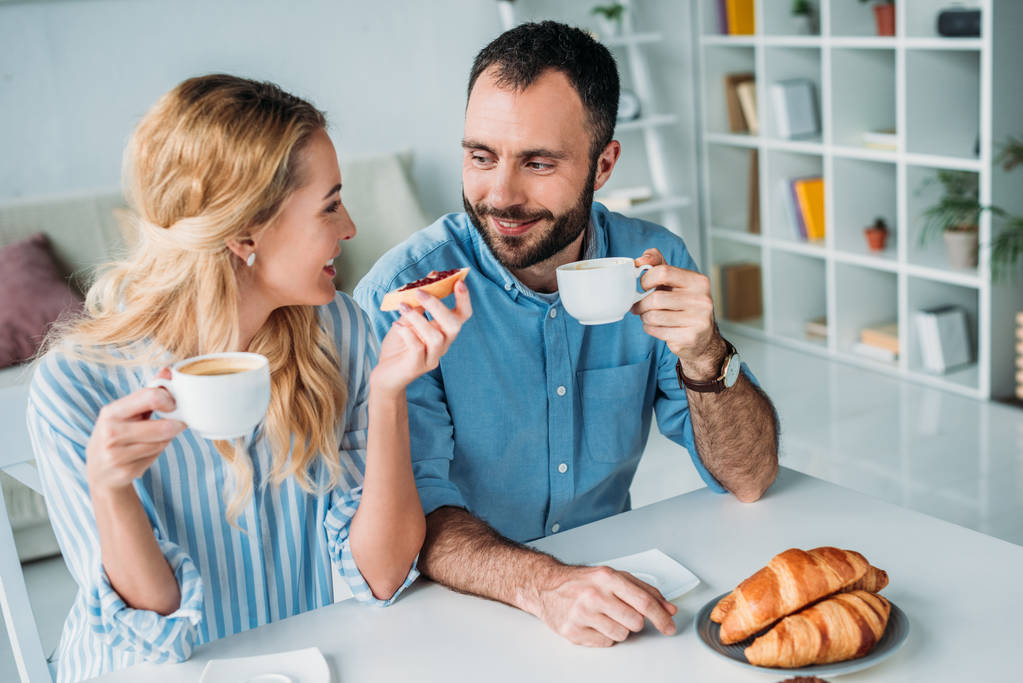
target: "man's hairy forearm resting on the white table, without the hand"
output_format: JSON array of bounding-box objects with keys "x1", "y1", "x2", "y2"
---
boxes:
[{"x1": 419, "y1": 507, "x2": 564, "y2": 614}]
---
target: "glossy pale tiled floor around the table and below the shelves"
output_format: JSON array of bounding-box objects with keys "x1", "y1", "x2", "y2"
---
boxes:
[{"x1": 0, "y1": 337, "x2": 1023, "y2": 681}]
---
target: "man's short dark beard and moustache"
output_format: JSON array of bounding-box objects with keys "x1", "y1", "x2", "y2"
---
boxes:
[{"x1": 461, "y1": 165, "x2": 596, "y2": 270}]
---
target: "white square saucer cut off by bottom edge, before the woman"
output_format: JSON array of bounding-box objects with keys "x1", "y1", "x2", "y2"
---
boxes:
[{"x1": 198, "y1": 647, "x2": 330, "y2": 683}]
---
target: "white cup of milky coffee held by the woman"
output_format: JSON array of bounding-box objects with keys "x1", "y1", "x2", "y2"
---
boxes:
[{"x1": 147, "y1": 352, "x2": 270, "y2": 440}]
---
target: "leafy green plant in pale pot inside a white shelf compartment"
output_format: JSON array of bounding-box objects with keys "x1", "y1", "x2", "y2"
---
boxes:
[{"x1": 918, "y1": 169, "x2": 985, "y2": 268}]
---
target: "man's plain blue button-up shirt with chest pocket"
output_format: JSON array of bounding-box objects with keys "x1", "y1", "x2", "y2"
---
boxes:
[{"x1": 355, "y1": 203, "x2": 744, "y2": 541}]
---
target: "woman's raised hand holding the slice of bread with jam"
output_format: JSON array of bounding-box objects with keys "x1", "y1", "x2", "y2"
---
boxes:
[{"x1": 370, "y1": 282, "x2": 473, "y2": 392}]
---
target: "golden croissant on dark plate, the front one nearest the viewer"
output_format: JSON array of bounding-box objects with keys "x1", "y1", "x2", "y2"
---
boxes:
[{"x1": 745, "y1": 591, "x2": 891, "y2": 669}]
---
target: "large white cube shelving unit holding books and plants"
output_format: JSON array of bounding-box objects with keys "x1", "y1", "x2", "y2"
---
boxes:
[{"x1": 696, "y1": 0, "x2": 1023, "y2": 398}]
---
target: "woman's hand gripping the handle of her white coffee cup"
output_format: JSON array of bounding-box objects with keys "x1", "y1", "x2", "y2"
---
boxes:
[{"x1": 85, "y1": 368, "x2": 185, "y2": 493}]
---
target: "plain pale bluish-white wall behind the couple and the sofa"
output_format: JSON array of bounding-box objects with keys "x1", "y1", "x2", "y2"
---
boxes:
[{"x1": 0, "y1": 0, "x2": 699, "y2": 258}]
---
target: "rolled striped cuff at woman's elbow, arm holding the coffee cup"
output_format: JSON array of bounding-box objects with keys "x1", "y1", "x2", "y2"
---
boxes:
[{"x1": 86, "y1": 539, "x2": 203, "y2": 663}]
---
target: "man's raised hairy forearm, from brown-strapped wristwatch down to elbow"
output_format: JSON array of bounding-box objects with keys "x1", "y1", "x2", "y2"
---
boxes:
[{"x1": 686, "y1": 374, "x2": 779, "y2": 502}]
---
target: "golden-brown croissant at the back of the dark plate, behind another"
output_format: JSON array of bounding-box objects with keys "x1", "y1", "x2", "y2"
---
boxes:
[{"x1": 720, "y1": 547, "x2": 871, "y2": 645}]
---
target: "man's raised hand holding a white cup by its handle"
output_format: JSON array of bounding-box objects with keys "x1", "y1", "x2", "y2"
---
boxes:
[{"x1": 632, "y1": 248, "x2": 725, "y2": 381}]
